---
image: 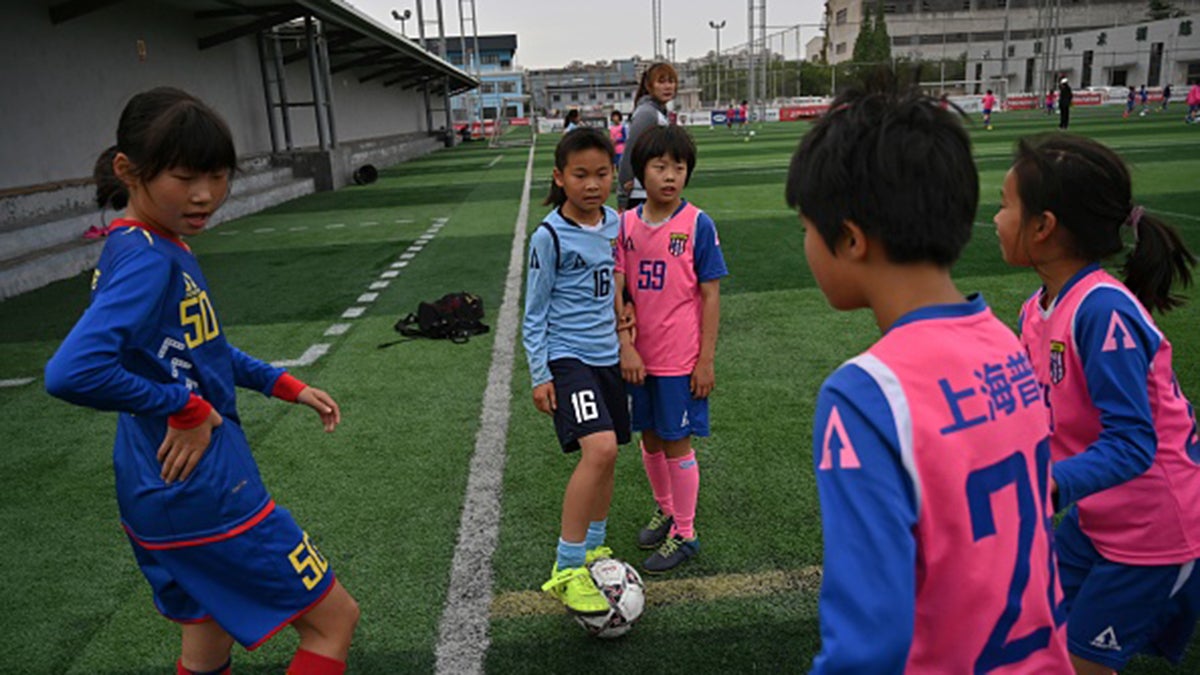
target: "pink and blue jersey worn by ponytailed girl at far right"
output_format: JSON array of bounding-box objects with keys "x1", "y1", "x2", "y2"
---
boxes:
[{"x1": 1021, "y1": 268, "x2": 1200, "y2": 565}]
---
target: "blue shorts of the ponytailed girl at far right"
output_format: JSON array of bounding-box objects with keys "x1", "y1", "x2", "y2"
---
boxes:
[{"x1": 1055, "y1": 507, "x2": 1200, "y2": 671}]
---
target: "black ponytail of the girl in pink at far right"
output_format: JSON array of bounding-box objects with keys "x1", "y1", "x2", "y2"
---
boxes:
[{"x1": 1122, "y1": 207, "x2": 1196, "y2": 312}]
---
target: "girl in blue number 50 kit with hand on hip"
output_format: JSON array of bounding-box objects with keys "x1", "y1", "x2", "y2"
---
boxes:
[{"x1": 46, "y1": 88, "x2": 359, "y2": 675}]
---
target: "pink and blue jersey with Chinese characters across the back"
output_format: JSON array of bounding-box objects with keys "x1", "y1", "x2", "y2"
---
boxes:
[{"x1": 814, "y1": 297, "x2": 1070, "y2": 675}]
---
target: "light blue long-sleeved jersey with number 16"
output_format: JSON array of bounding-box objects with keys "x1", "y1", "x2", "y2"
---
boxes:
[{"x1": 522, "y1": 207, "x2": 620, "y2": 387}]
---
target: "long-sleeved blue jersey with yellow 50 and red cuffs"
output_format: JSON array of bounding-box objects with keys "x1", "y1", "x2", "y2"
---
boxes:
[{"x1": 46, "y1": 221, "x2": 283, "y2": 546}]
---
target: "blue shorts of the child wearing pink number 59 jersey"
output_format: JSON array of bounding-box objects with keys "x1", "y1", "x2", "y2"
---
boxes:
[{"x1": 629, "y1": 375, "x2": 708, "y2": 441}]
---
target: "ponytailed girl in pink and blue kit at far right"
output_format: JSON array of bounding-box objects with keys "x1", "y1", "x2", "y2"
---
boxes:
[{"x1": 995, "y1": 135, "x2": 1200, "y2": 674}]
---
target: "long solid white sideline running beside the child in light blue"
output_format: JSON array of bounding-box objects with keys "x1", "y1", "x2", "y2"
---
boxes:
[{"x1": 436, "y1": 142, "x2": 536, "y2": 675}]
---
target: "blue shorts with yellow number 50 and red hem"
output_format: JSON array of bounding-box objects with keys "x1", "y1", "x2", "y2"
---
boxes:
[{"x1": 130, "y1": 504, "x2": 334, "y2": 650}]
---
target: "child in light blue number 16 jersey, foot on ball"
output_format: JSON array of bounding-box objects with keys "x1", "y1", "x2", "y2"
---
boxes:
[{"x1": 523, "y1": 127, "x2": 630, "y2": 614}]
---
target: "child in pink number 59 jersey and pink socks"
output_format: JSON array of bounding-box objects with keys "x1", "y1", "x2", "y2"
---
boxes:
[{"x1": 617, "y1": 126, "x2": 728, "y2": 574}]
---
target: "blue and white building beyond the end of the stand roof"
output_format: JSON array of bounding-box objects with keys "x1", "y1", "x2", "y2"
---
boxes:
[{"x1": 425, "y1": 34, "x2": 529, "y2": 124}]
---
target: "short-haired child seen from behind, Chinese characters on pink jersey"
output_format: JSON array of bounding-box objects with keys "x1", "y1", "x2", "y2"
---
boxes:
[{"x1": 787, "y1": 81, "x2": 1070, "y2": 675}]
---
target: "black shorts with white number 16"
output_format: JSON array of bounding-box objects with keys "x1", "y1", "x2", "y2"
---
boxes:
[{"x1": 550, "y1": 359, "x2": 631, "y2": 453}]
